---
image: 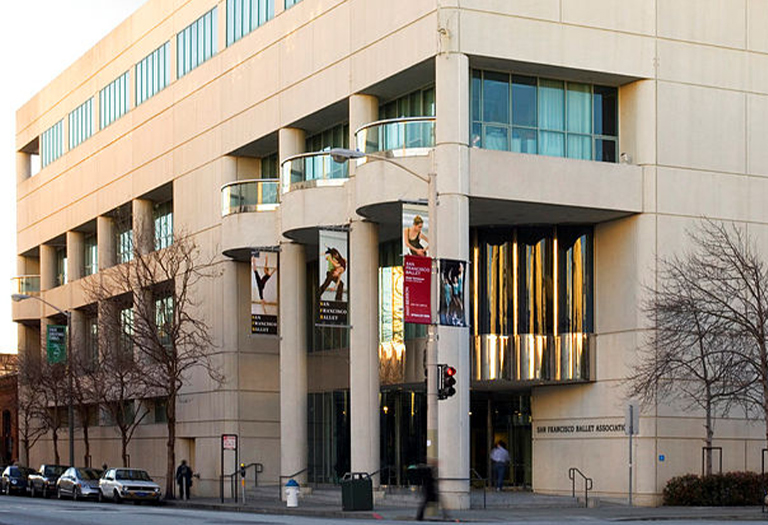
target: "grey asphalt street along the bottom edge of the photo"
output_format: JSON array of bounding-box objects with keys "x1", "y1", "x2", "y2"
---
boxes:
[{"x1": 0, "y1": 496, "x2": 765, "y2": 525}]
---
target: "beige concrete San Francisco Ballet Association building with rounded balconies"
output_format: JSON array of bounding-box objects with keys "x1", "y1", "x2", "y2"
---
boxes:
[{"x1": 13, "y1": 0, "x2": 768, "y2": 507}]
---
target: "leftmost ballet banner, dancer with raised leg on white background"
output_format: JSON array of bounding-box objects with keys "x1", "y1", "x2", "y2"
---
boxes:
[{"x1": 251, "y1": 252, "x2": 279, "y2": 335}]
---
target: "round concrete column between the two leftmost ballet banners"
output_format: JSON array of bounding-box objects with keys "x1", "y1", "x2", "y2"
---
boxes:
[{"x1": 278, "y1": 241, "x2": 308, "y2": 488}]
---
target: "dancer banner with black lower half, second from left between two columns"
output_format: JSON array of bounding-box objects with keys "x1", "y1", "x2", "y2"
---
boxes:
[{"x1": 317, "y1": 230, "x2": 349, "y2": 326}]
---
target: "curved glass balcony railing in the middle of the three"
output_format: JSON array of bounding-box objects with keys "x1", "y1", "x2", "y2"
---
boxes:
[{"x1": 282, "y1": 152, "x2": 349, "y2": 193}]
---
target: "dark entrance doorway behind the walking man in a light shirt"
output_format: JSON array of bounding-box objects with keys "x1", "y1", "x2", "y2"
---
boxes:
[{"x1": 470, "y1": 390, "x2": 533, "y2": 489}]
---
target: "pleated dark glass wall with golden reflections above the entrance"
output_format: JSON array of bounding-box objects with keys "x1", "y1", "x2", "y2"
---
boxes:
[{"x1": 472, "y1": 226, "x2": 594, "y2": 381}]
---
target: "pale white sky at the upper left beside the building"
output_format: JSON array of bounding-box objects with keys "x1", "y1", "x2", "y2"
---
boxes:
[{"x1": 0, "y1": 0, "x2": 146, "y2": 353}]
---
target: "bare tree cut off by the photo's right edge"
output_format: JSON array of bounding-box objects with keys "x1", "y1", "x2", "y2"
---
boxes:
[{"x1": 628, "y1": 220, "x2": 768, "y2": 472}]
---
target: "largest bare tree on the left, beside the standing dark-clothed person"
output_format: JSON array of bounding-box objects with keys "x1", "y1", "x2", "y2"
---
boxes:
[{"x1": 86, "y1": 224, "x2": 223, "y2": 499}]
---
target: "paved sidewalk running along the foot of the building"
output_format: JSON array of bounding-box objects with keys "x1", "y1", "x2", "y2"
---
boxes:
[{"x1": 167, "y1": 498, "x2": 768, "y2": 522}]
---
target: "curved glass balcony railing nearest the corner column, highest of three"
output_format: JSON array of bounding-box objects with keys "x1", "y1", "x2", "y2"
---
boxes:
[{"x1": 355, "y1": 117, "x2": 435, "y2": 157}]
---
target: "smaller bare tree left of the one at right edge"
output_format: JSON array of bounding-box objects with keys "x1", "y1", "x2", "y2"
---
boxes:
[{"x1": 628, "y1": 239, "x2": 745, "y2": 474}]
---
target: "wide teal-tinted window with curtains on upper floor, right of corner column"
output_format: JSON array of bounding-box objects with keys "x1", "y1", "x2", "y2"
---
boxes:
[{"x1": 471, "y1": 70, "x2": 618, "y2": 162}]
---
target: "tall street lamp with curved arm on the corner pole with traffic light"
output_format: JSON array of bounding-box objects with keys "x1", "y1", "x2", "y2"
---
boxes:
[{"x1": 329, "y1": 148, "x2": 438, "y2": 465}]
